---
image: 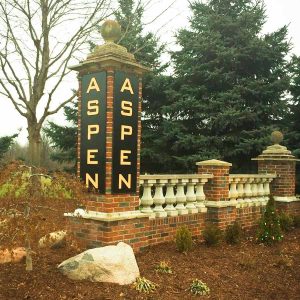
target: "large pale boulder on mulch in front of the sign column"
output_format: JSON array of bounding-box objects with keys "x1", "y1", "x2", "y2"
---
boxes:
[{"x1": 58, "y1": 242, "x2": 140, "y2": 285}]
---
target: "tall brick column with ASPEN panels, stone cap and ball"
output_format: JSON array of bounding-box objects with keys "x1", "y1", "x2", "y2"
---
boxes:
[{"x1": 66, "y1": 20, "x2": 149, "y2": 247}]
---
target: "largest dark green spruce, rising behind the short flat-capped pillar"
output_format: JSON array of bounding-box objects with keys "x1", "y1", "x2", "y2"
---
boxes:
[{"x1": 162, "y1": 0, "x2": 290, "y2": 172}]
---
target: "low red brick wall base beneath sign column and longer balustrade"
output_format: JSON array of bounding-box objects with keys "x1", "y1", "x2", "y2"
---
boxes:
[{"x1": 69, "y1": 213, "x2": 206, "y2": 252}]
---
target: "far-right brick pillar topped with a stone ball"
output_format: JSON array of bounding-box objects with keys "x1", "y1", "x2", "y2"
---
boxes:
[{"x1": 252, "y1": 131, "x2": 300, "y2": 214}]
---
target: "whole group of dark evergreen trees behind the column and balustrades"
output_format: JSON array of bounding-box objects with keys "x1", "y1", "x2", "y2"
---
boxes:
[{"x1": 0, "y1": 0, "x2": 300, "y2": 184}]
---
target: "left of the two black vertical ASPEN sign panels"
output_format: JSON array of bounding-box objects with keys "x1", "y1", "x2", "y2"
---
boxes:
[{"x1": 80, "y1": 72, "x2": 106, "y2": 193}]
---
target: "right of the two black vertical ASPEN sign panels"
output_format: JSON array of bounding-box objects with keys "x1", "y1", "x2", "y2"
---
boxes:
[{"x1": 112, "y1": 72, "x2": 139, "y2": 194}]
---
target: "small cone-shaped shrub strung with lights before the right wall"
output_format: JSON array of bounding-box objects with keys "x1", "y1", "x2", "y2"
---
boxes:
[{"x1": 257, "y1": 196, "x2": 283, "y2": 245}]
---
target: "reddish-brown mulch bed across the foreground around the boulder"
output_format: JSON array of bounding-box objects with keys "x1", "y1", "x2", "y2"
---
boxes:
[{"x1": 0, "y1": 229, "x2": 300, "y2": 300}]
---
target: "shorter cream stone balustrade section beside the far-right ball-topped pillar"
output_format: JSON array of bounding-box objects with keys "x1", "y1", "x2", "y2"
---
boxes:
[{"x1": 229, "y1": 174, "x2": 276, "y2": 208}]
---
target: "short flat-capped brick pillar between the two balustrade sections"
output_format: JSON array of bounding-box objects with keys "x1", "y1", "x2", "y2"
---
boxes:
[{"x1": 196, "y1": 159, "x2": 236, "y2": 229}]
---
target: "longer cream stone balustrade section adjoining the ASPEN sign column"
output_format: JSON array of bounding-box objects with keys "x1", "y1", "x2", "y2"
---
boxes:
[{"x1": 140, "y1": 174, "x2": 213, "y2": 217}]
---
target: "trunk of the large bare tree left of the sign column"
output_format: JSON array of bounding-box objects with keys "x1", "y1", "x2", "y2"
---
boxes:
[{"x1": 27, "y1": 121, "x2": 41, "y2": 167}]
